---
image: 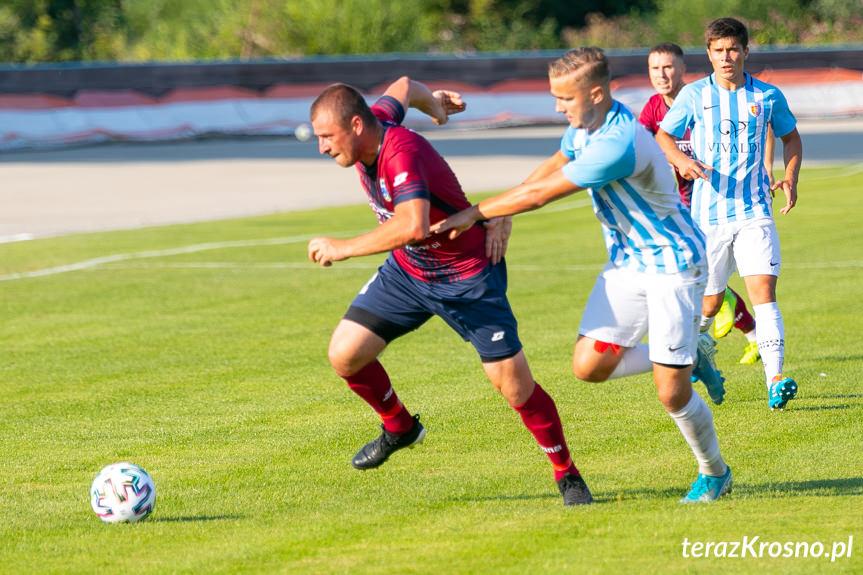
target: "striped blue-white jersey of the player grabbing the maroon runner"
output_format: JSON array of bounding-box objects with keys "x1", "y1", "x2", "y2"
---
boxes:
[{"x1": 560, "y1": 101, "x2": 705, "y2": 274}]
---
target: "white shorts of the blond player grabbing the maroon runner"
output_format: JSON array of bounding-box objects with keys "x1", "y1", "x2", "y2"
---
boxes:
[{"x1": 578, "y1": 263, "x2": 707, "y2": 365}]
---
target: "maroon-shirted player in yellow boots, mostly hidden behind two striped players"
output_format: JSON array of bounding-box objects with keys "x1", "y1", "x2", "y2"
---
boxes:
[{"x1": 638, "y1": 42, "x2": 761, "y2": 364}]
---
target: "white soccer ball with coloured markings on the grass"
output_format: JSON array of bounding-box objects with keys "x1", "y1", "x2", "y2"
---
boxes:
[{"x1": 90, "y1": 461, "x2": 156, "y2": 523}]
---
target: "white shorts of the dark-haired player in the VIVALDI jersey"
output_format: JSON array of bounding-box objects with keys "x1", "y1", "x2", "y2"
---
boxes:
[{"x1": 704, "y1": 218, "x2": 782, "y2": 295}]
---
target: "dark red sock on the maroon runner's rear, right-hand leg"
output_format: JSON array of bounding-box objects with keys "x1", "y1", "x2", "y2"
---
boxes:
[{"x1": 513, "y1": 384, "x2": 580, "y2": 481}]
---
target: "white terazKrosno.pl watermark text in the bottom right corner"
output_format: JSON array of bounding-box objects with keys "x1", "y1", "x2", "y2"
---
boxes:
[{"x1": 683, "y1": 535, "x2": 854, "y2": 563}]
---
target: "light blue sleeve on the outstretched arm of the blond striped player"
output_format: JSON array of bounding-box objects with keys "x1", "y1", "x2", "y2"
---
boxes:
[{"x1": 562, "y1": 123, "x2": 643, "y2": 188}]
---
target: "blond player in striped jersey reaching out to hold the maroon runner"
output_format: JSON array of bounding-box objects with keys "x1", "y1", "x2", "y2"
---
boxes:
[{"x1": 432, "y1": 47, "x2": 731, "y2": 503}]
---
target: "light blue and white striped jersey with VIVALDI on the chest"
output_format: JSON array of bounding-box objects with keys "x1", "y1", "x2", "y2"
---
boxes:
[{"x1": 659, "y1": 74, "x2": 797, "y2": 229}]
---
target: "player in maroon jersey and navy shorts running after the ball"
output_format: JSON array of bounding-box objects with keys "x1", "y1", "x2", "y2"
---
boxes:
[{"x1": 308, "y1": 77, "x2": 593, "y2": 505}]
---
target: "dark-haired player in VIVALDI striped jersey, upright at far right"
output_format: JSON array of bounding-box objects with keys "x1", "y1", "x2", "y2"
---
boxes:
[{"x1": 656, "y1": 18, "x2": 803, "y2": 410}]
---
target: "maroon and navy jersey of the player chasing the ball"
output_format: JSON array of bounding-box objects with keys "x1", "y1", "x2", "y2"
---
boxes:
[{"x1": 356, "y1": 96, "x2": 489, "y2": 282}]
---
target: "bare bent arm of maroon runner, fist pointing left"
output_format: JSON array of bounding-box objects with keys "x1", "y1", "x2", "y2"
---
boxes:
[{"x1": 309, "y1": 198, "x2": 429, "y2": 266}]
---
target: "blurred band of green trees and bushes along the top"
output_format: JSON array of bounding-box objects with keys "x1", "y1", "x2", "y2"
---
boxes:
[{"x1": 0, "y1": 0, "x2": 863, "y2": 62}]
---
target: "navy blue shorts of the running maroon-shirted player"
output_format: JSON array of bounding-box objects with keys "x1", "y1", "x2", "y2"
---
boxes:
[{"x1": 345, "y1": 256, "x2": 522, "y2": 362}]
